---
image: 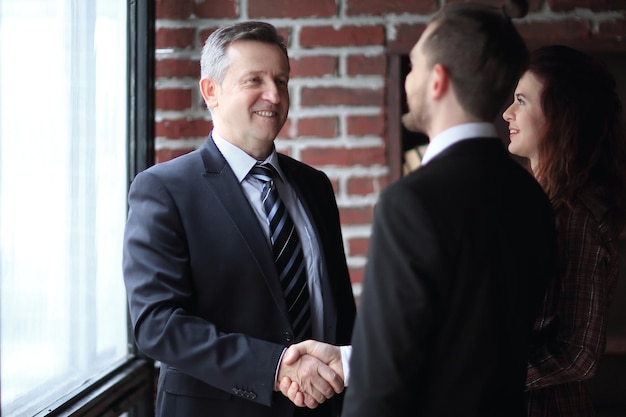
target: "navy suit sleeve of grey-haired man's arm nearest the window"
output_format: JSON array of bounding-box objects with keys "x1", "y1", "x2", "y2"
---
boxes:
[{"x1": 123, "y1": 167, "x2": 283, "y2": 405}]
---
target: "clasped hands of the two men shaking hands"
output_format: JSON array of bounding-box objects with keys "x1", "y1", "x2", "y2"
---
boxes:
[{"x1": 276, "y1": 340, "x2": 350, "y2": 408}]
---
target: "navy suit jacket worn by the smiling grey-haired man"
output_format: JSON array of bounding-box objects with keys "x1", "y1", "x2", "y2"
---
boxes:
[{"x1": 123, "y1": 138, "x2": 355, "y2": 417}]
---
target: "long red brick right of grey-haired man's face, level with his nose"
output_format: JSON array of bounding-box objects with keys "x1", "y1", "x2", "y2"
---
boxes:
[{"x1": 301, "y1": 87, "x2": 384, "y2": 107}]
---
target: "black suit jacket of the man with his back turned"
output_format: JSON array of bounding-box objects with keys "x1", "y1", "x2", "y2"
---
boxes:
[{"x1": 342, "y1": 138, "x2": 556, "y2": 417}]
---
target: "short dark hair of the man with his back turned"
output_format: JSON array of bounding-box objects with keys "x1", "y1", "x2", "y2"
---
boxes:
[{"x1": 424, "y1": 0, "x2": 528, "y2": 122}]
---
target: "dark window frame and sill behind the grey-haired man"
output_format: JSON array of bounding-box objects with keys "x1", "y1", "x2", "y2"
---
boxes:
[{"x1": 26, "y1": 0, "x2": 156, "y2": 417}]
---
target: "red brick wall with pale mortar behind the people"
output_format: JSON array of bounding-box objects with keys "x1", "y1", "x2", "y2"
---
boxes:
[{"x1": 155, "y1": 0, "x2": 626, "y2": 296}]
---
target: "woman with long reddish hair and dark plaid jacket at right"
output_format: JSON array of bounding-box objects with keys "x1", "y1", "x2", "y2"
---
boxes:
[{"x1": 503, "y1": 46, "x2": 626, "y2": 417}]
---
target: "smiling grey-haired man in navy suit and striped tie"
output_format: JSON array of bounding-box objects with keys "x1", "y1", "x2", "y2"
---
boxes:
[{"x1": 123, "y1": 22, "x2": 355, "y2": 417}]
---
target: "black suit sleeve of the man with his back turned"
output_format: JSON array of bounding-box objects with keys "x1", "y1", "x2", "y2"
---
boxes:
[{"x1": 343, "y1": 184, "x2": 441, "y2": 417}]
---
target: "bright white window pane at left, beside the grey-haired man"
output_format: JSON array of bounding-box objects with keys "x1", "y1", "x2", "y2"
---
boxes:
[{"x1": 0, "y1": 0, "x2": 129, "y2": 417}]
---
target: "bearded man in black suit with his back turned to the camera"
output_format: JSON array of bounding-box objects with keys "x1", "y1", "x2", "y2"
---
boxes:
[{"x1": 342, "y1": 3, "x2": 556, "y2": 417}]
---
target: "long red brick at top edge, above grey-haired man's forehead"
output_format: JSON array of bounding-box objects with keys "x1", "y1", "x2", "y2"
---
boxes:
[{"x1": 248, "y1": 0, "x2": 337, "y2": 19}]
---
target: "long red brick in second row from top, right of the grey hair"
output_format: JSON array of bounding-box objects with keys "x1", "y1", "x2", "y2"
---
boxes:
[{"x1": 300, "y1": 26, "x2": 385, "y2": 48}]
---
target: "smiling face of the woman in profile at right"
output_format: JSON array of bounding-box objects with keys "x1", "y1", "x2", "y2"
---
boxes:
[{"x1": 502, "y1": 71, "x2": 547, "y2": 168}]
